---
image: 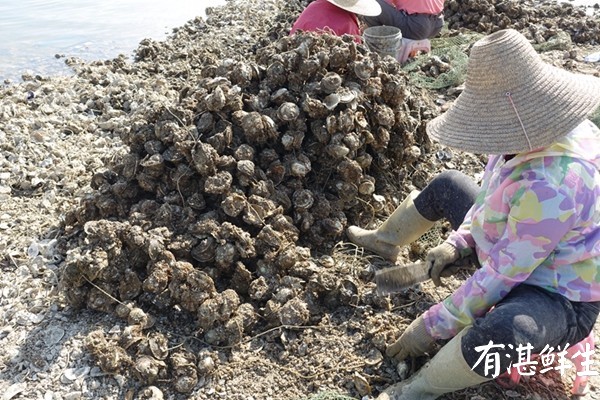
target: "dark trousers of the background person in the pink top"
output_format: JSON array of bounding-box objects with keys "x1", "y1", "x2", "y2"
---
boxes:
[{"x1": 361, "y1": 0, "x2": 444, "y2": 40}]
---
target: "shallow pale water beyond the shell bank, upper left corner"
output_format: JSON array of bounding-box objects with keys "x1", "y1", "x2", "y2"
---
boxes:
[{"x1": 0, "y1": 0, "x2": 225, "y2": 82}]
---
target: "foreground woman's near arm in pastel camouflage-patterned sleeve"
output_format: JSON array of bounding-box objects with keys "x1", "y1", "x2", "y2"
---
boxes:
[{"x1": 424, "y1": 181, "x2": 576, "y2": 339}]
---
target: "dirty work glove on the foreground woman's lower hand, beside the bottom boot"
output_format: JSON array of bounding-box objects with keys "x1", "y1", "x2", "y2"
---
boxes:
[{"x1": 385, "y1": 315, "x2": 435, "y2": 362}]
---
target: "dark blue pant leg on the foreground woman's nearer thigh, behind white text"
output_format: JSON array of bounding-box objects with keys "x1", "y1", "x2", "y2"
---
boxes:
[{"x1": 461, "y1": 284, "x2": 600, "y2": 378}]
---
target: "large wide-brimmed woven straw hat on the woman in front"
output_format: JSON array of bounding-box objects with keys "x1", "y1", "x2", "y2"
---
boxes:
[{"x1": 427, "y1": 29, "x2": 600, "y2": 154}]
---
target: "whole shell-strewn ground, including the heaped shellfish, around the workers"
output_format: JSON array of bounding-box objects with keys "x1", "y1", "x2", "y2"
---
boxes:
[{"x1": 0, "y1": 0, "x2": 600, "y2": 400}]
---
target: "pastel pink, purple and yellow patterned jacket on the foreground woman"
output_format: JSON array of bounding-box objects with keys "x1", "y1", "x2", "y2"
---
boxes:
[{"x1": 424, "y1": 120, "x2": 600, "y2": 339}]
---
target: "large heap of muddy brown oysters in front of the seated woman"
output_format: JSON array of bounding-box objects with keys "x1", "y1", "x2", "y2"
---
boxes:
[{"x1": 56, "y1": 34, "x2": 435, "y2": 391}]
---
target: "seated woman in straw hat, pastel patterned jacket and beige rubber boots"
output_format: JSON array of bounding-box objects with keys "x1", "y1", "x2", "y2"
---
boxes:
[{"x1": 348, "y1": 29, "x2": 600, "y2": 400}]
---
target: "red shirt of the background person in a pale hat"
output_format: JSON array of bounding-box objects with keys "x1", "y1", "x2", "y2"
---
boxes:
[{"x1": 290, "y1": 0, "x2": 361, "y2": 41}]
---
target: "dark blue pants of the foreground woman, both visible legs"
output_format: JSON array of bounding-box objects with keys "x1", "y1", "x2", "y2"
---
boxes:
[{"x1": 414, "y1": 170, "x2": 600, "y2": 378}]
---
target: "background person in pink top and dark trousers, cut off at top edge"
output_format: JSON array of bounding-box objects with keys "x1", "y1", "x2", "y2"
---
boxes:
[{"x1": 362, "y1": 0, "x2": 444, "y2": 40}]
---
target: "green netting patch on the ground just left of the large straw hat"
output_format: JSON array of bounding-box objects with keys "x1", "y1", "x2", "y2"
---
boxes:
[{"x1": 402, "y1": 33, "x2": 484, "y2": 90}]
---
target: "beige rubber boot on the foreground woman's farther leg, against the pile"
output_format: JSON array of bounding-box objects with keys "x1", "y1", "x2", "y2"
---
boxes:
[{"x1": 346, "y1": 190, "x2": 435, "y2": 261}]
